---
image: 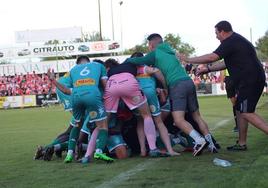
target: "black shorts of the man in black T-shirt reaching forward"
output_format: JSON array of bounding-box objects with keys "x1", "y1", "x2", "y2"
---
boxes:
[{"x1": 235, "y1": 82, "x2": 265, "y2": 113}]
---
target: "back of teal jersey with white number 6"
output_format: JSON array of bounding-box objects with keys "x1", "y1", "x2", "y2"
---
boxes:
[{"x1": 70, "y1": 62, "x2": 106, "y2": 92}]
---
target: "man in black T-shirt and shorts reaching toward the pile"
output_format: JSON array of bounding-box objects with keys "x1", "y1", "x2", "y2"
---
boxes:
[{"x1": 180, "y1": 21, "x2": 268, "y2": 150}]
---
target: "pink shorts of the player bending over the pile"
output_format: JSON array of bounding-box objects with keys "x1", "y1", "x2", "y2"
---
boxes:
[{"x1": 104, "y1": 73, "x2": 147, "y2": 113}]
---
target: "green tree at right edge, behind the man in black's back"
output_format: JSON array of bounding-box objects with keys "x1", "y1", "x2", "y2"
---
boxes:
[{"x1": 256, "y1": 31, "x2": 268, "y2": 61}]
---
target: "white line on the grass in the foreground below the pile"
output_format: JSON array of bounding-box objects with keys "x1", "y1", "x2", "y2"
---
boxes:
[{"x1": 97, "y1": 158, "x2": 160, "y2": 188}]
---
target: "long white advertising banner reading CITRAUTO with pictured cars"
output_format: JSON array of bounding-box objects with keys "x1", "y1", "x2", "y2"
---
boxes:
[{"x1": 0, "y1": 41, "x2": 121, "y2": 60}]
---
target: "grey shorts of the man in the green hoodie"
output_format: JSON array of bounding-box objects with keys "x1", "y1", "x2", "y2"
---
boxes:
[{"x1": 169, "y1": 80, "x2": 199, "y2": 112}]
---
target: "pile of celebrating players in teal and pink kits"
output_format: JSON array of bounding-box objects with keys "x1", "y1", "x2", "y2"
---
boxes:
[{"x1": 34, "y1": 34, "x2": 220, "y2": 164}]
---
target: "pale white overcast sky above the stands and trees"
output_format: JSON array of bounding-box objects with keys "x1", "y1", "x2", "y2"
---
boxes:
[{"x1": 0, "y1": 0, "x2": 268, "y2": 55}]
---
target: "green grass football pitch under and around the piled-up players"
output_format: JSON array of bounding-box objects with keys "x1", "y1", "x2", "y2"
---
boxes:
[{"x1": 0, "y1": 96, "x2": 268, "y2": 188}]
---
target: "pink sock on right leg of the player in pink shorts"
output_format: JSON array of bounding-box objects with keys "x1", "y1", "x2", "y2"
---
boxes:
[{"x1": 144, "y1": 117, "x2": 156, "y2": 150}]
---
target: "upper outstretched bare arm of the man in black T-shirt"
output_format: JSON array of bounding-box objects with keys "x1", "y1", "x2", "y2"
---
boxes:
[{"x1": 178, "y1": 53, "x2": 220, "y2": 64}]
